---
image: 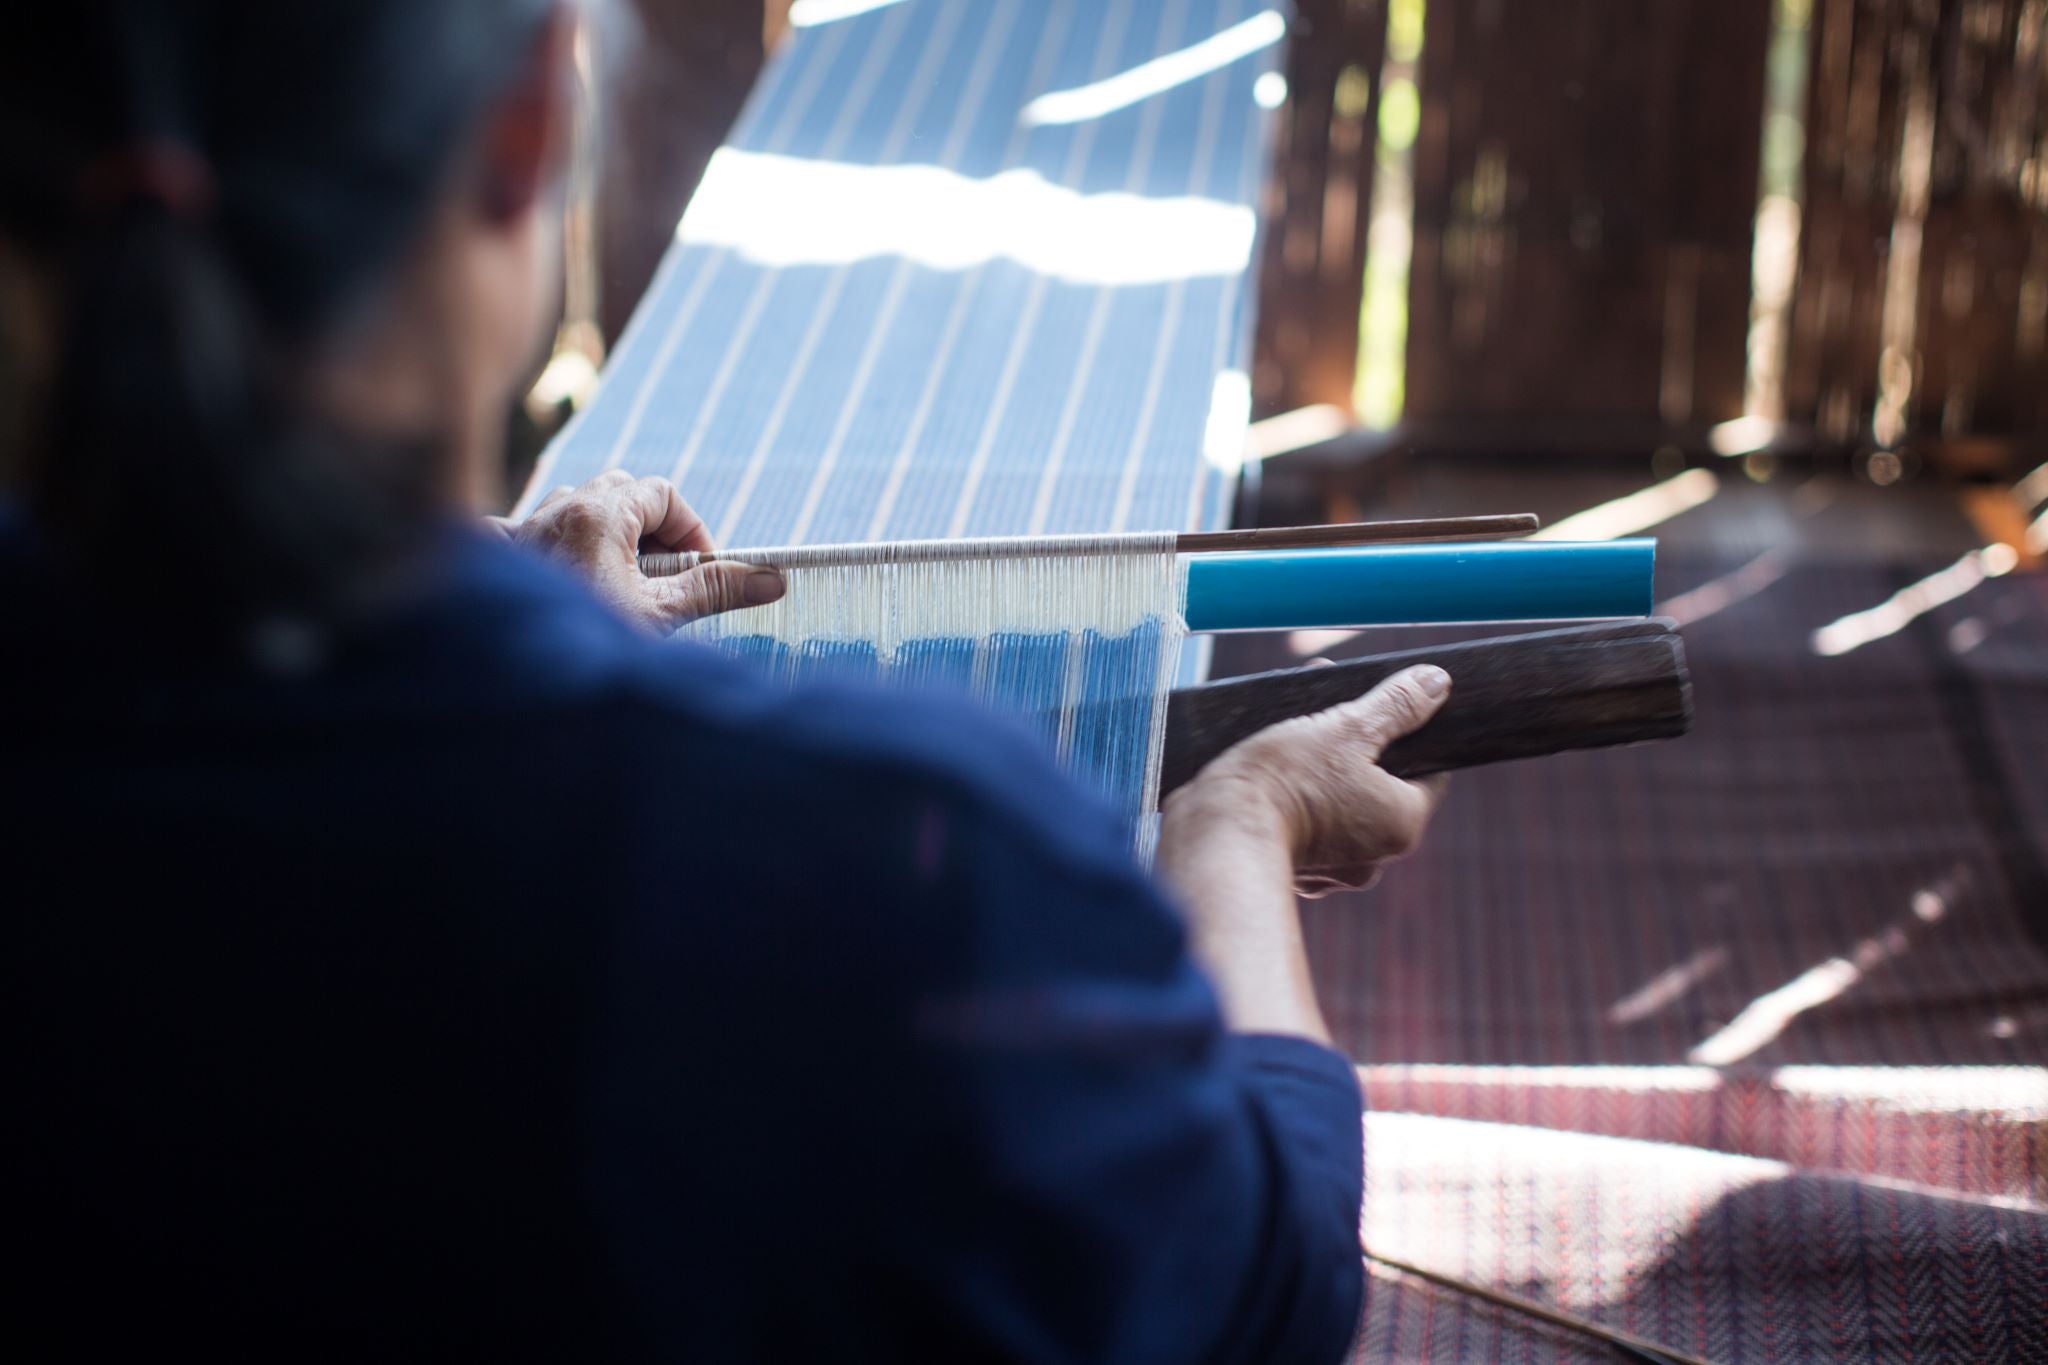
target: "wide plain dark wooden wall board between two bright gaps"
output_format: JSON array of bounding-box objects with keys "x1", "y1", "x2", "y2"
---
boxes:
[{"x1": 1407, "y1": 0, "x2": 1769, "y2": 424}]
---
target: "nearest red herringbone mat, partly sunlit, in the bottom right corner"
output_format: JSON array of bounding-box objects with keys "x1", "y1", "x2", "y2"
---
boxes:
[{"x1": 1356, "y1": 1113, "x2": 2048, "y2": 1365}]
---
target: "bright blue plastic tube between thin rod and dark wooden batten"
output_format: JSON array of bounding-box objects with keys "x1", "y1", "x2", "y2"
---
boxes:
[{"x1": 1188, "y1": 540, "x2": 1657, "y2": 630}]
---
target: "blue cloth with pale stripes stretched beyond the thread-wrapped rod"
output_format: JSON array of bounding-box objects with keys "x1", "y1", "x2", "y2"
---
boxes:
[{"x1": 524, "y1": 0, "x2": 1282, "y2": 544}]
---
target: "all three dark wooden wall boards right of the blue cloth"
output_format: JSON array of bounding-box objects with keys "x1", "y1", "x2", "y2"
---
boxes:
[{"x1": 1257, "y1": 0, "x2": 2048, "y2": 454}]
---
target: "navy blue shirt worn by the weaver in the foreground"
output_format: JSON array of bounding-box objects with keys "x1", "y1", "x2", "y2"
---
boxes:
[{"x1": 16, "y1": 524, "x2": 1362, "y2": 1363}]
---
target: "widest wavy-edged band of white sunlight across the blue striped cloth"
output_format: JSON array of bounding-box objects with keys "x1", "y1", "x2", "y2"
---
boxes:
[{"x1": 676, "y1": 147, "x2": 1257, "y2": 284}]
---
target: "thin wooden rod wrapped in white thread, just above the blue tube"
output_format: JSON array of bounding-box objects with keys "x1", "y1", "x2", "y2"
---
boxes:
[{"x1": 641, "y1": 512, "x2": 1540, "y2": 577}]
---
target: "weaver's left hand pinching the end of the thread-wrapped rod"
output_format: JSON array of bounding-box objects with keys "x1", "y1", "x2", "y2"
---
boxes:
[{"x1": 485, "y1": 469, "x2": 782, "y2": 632}]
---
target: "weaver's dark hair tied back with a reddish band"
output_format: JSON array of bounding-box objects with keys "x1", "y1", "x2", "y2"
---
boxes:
[{"x1": 0, "y1": 0, "x2": 555, "y2": 630}]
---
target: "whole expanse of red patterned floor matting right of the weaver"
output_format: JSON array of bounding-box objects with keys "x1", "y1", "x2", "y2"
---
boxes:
[{"x1": 1219, "y1": 519, "x2": 2048, "y2": 1361}]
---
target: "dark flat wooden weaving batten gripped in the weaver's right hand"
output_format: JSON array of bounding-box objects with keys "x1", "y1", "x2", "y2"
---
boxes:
[{"x1": 1159, "y1": 618, "x2": 1692, "y2": 796}]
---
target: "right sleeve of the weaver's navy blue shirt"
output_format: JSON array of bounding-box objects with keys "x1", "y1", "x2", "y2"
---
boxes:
[{"x1": 876, "y1": 769, "x2": 1364, "y2": 1363}]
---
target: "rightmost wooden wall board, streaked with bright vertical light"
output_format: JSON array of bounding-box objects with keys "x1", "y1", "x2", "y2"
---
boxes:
[{"x1": 1786, "y1": 0, "x2": 2048, "y2": 448}]
